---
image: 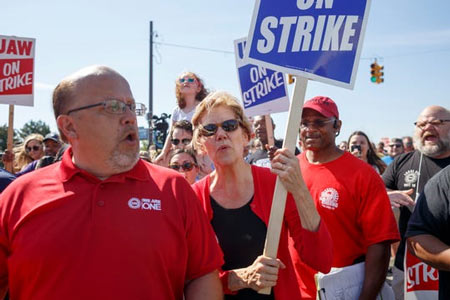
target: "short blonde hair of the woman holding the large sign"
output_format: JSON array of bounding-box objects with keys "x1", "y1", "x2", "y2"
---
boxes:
[{"x1": 192, "y1": 91, "x2": 252, "y2": 149}]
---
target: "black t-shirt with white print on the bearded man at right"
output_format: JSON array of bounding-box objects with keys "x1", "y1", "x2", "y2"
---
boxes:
[{"x1": 383, "y1": 150, "x2": 450, "y2": 270}]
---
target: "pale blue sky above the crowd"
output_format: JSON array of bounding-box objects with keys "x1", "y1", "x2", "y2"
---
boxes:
[{"x1": 0, "y1": 0, "x2": 450, "y2": 142}]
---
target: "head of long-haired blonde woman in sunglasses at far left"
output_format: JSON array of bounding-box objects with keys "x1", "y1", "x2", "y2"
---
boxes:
[{"x1": 13, "y1": 134, "x2": 44, "y2": 175}]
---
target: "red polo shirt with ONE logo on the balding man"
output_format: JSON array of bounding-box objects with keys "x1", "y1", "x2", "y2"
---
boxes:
[{"x1": 0, "y1": 149, "x2": 223, "y2": 300}]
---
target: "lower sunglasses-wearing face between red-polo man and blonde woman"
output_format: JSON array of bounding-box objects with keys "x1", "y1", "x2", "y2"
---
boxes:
[{"x1": 169, "y1": 148, "x2": 198, "y2": 184}]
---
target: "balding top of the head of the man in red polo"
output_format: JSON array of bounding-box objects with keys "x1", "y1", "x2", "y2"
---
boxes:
[{"x1": 53, "y1": 66, "x2": 129, "y2": 119}]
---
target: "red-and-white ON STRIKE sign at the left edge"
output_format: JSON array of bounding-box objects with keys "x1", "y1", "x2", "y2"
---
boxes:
[{"x1": 0, "y1": 35, "x2": 36, "y2": 106}]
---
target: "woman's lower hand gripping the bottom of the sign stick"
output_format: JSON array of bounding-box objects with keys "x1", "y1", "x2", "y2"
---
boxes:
[{"x1": 228, "y1": 255, "x2": 286, "y2": 291}]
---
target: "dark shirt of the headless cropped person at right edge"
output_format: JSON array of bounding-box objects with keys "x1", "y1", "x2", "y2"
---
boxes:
[{"x1": 406, "y1": 166, "x2": 450, "y2": 300}]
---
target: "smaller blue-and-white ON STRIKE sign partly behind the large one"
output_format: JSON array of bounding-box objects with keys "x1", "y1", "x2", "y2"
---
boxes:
[{"x1": 235, "y1": 38, "x2": 289, "y2": 117}]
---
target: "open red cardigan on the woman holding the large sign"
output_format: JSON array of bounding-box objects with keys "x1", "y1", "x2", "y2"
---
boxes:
[{"x1": 193, "y1": 165, "x2": 333, "y2": 300}]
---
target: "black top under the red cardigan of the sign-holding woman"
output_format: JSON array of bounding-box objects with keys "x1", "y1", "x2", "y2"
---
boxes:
[{"x1": 210, "y1": 197, "x2": 274, "y2": 300}]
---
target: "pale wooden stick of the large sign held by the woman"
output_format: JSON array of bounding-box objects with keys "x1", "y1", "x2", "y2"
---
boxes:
[{"x1": 258, "y1": 76, "x2": 308, "y2": 295}]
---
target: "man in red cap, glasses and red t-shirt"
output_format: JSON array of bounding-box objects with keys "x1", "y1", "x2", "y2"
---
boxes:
[{"x1": 290, "y1": 96, "x2": 399, "y2": 299}]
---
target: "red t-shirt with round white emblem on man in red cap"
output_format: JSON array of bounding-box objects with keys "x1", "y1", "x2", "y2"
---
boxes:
[{"x1": 296, "y1": 152, "x2": 400, "y2": 294}]
